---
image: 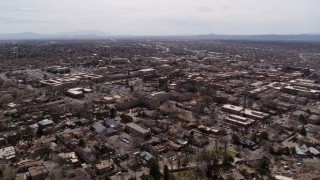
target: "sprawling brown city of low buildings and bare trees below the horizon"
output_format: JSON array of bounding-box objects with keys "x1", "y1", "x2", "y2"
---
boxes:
[{"x1": 0, "y1": 38, "x2": 320, "y2": 180}]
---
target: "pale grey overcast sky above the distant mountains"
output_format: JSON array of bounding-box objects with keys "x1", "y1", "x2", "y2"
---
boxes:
[{"x1": 0, "y1": 0, "x2": 320, "y2": 35}]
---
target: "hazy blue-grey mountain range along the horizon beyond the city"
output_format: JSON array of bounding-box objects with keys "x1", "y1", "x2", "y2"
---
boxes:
[{"x1": 0, "y1": 30, "x2": 320, "y2": 41}]
